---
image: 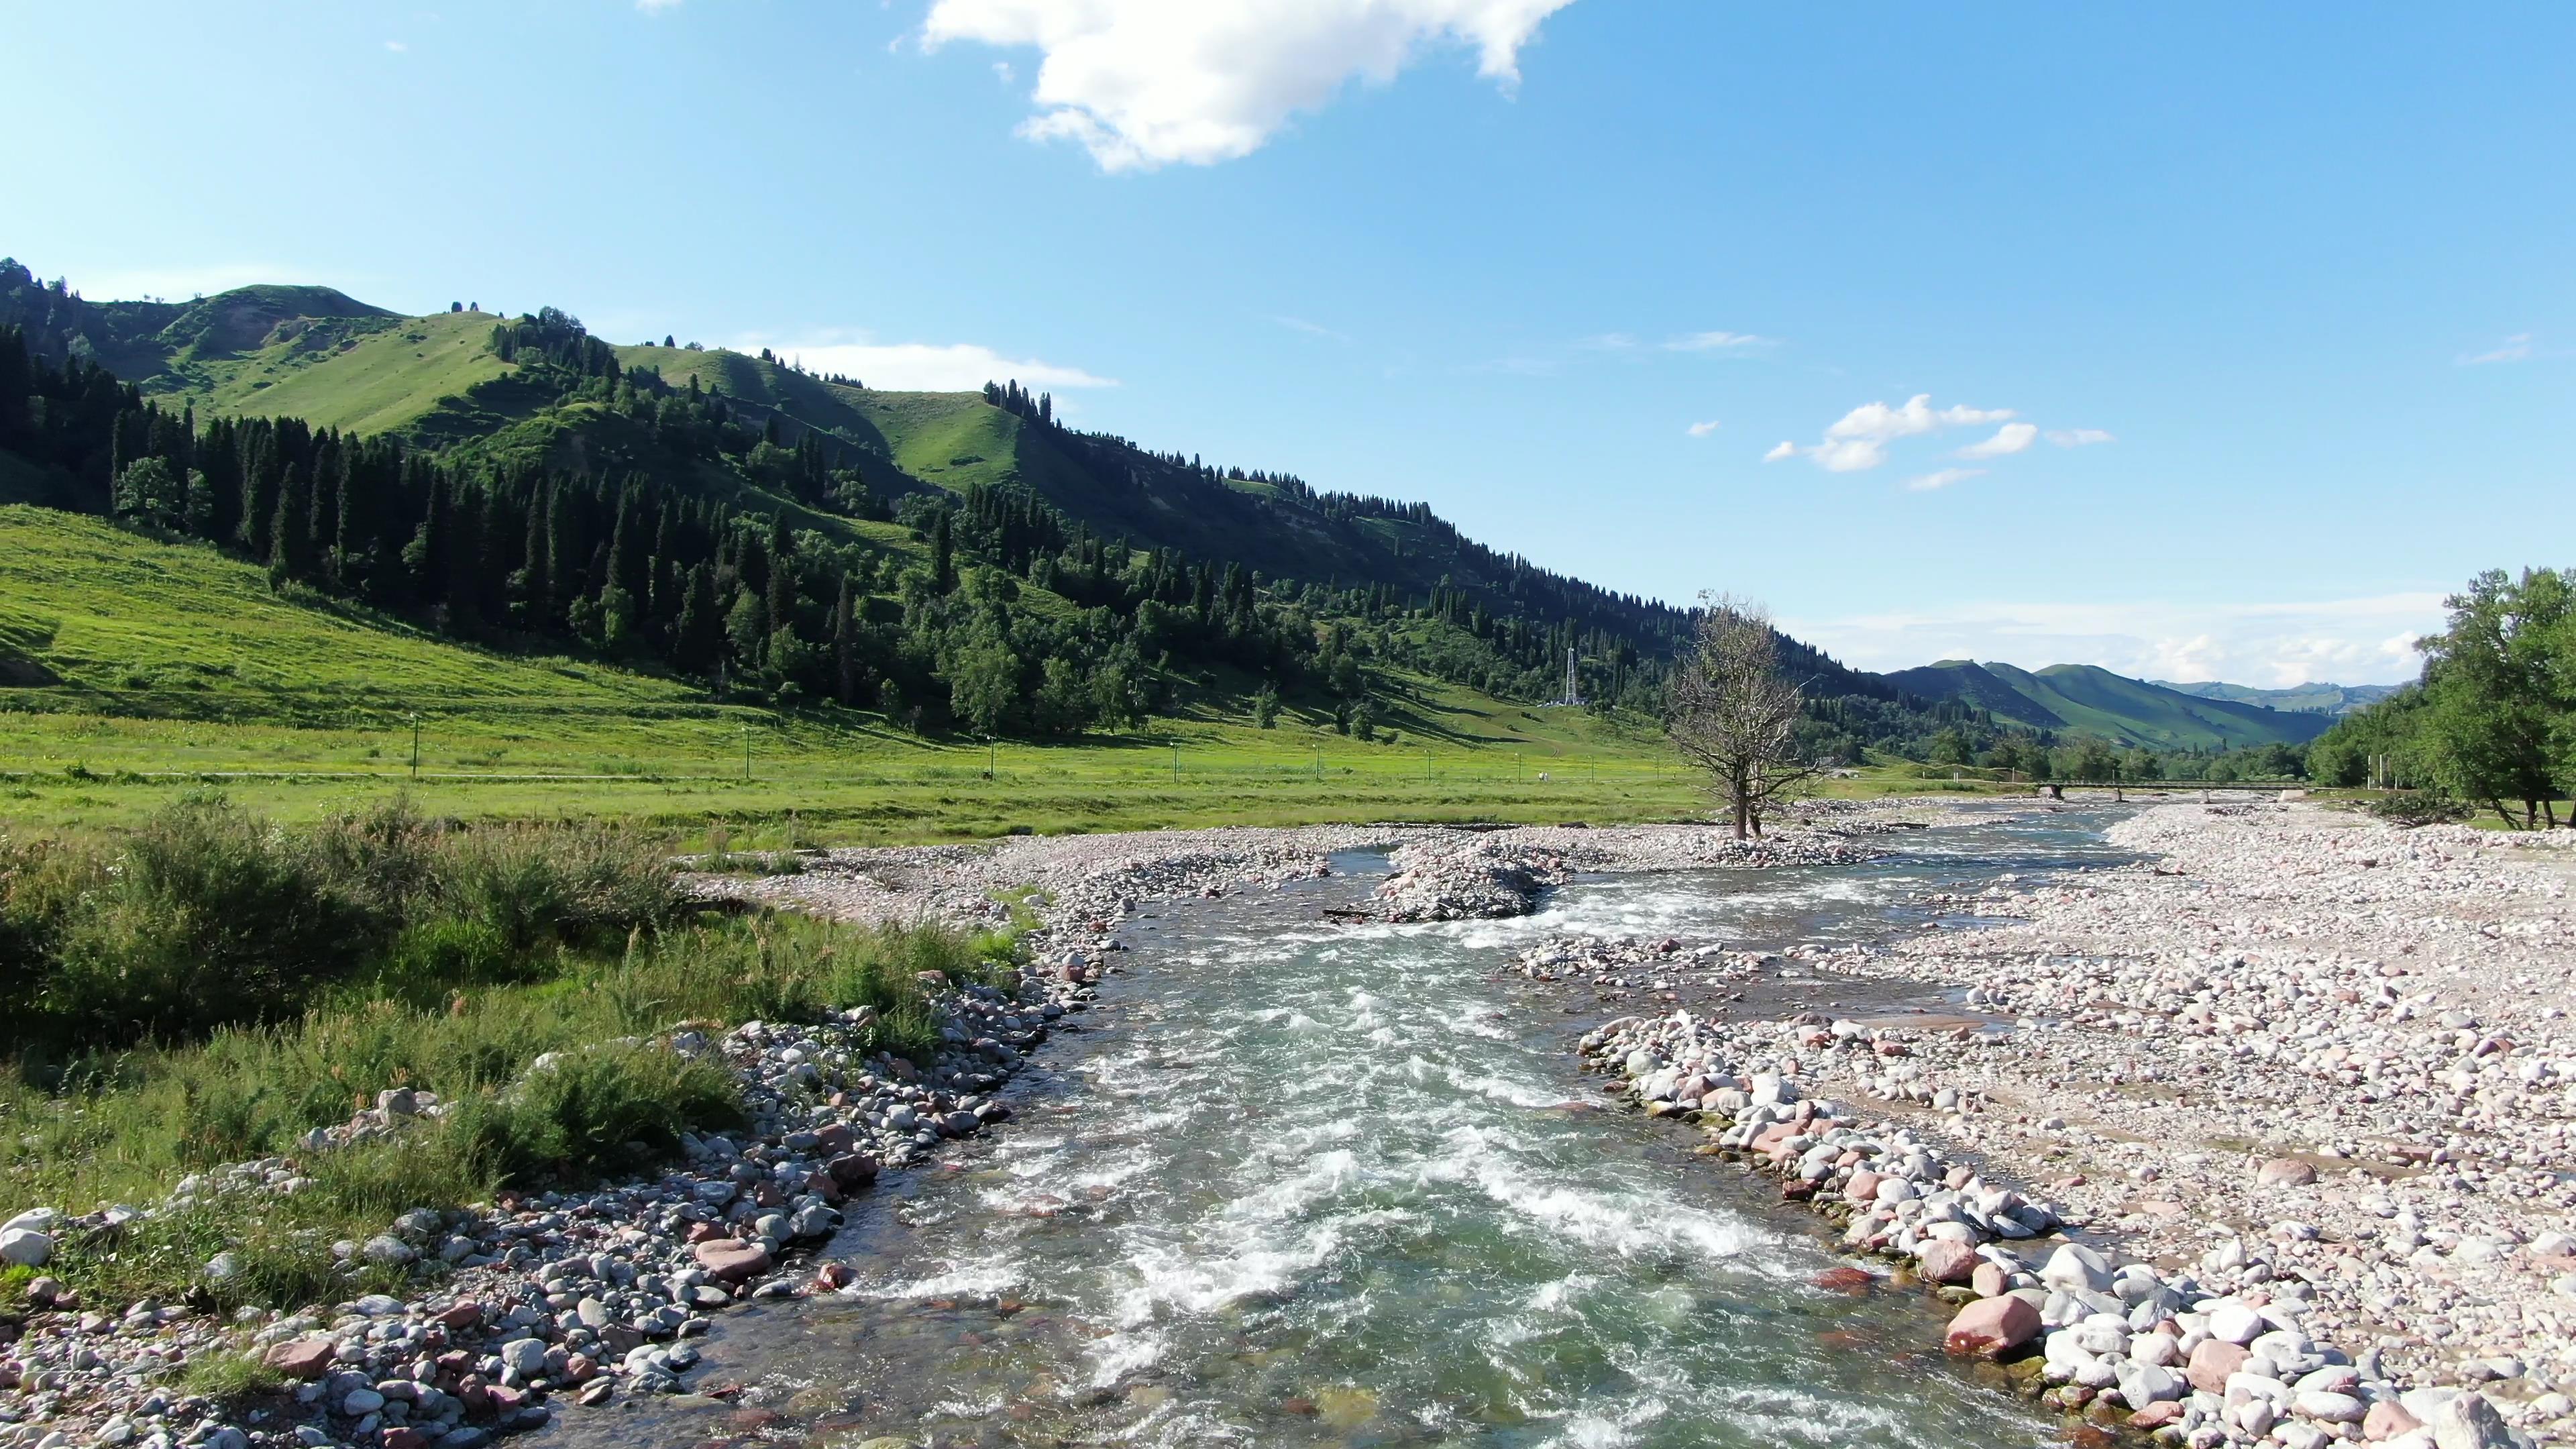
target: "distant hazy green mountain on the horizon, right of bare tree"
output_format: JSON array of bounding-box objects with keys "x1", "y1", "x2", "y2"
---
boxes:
[{"x1": 1886, "y1": 660, "x2": 2334, "y2": 750}]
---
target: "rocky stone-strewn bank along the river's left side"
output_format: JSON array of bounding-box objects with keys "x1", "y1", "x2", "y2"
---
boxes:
[{"x1": 0, "y1": 810, "x2": 1891, "y2": 1449}]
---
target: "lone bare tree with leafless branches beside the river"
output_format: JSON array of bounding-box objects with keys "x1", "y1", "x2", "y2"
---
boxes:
[{"x1": 1664, "y1": 593, "x2": 1824, "y2": 841}]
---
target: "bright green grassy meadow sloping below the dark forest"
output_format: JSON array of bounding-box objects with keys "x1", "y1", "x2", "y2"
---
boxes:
[{"x1": 0, "y1": 508, "x2": 1700, "y2": 843}]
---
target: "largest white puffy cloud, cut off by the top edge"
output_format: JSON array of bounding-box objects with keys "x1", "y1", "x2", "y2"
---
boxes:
[{"x1": 922, "y1": 0, "x2": 1574, "y2": 170}]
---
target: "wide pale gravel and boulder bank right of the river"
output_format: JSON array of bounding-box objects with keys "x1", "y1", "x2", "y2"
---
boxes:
[{"x1": 1566, "y1": 804, "x2": 2576, "y2": 1449}]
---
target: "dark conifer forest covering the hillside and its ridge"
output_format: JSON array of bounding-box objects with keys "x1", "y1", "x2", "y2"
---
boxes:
[{"x1": 0, "y1": 268, "x2": 1927, "y2": 758}]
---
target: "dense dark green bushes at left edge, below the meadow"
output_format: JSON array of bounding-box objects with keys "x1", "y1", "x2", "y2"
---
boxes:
[{"x1": 0, "y1": 794, "x2": 675, "y2": 1057}]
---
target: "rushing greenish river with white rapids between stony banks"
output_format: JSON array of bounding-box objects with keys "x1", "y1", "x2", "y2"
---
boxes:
[{"x1": 556, "y1": 812, "x2": 2117, "y2": 1449}]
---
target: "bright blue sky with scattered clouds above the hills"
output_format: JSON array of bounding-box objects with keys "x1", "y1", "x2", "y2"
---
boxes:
[{"x1": 0, "y1": 0, "x2": 2576, "y2": 684}]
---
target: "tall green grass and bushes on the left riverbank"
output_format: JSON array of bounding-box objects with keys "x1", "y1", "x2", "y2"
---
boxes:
[{"x1": 0, "y1": 802, "x2": 1010, "y2": 1305}]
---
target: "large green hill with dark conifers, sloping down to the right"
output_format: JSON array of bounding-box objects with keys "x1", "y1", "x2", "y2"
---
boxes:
[{"x1": 0, "y1": 260, "x2": 1927, "y2": 778}]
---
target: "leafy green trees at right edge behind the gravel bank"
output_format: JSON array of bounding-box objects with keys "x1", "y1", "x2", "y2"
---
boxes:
[{"x1": 2308, "y1": 568, "x2": 2576, "y2": 830}]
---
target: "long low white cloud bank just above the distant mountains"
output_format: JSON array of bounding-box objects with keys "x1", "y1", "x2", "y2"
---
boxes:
[{"x1": 1780, "y1": 593, "x2": 2442, "y2": 688}]
